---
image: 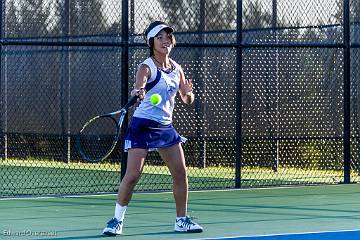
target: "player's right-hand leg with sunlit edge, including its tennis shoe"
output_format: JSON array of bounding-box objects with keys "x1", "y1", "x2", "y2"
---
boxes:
[{"x1": 159, "y1": 143, "x2": 203, "y2": 232}]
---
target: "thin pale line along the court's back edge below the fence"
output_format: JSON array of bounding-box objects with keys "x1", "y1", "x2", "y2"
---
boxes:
[{"x1": 0, "y1": 183, "x2": 354, "y2": 201}]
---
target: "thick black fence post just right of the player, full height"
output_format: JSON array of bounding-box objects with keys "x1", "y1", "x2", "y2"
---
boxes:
[{"x1": 235, "y1": 0, "x2": 243, "y2": 188}]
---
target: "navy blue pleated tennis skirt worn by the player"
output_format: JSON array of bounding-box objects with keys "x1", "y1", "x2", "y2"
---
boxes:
[{"x1": 124, "y1": 117, "x2": 187, "y2": 152}]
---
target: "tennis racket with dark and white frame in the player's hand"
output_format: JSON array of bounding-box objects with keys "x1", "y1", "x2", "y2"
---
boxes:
[{"x1": 76, "y1": 96, "x2": 138, "y2": 163}]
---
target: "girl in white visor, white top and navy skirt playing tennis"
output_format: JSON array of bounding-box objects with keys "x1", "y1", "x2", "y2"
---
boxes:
[{"x1": 103, "y1": 21, "x2": 203, "y2": 236}]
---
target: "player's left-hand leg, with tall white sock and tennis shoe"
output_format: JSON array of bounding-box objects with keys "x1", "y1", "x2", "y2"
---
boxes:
[{"x1": 103, "y1": 148, "x2": 148, "y2": 236}]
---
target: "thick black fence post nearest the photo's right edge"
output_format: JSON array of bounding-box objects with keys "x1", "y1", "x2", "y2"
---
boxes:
[{"x1": 343, "y1": 0, "x2": 351, "y2": 183}]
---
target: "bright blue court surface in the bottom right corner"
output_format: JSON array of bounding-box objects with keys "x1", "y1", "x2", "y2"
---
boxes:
[{"x1": 203, "y1": 229, "x2": 360, "y2": 240}]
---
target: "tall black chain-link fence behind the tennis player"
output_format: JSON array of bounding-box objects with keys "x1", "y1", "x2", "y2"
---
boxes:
[{"x1": 0, "y1": 0, "x2": 360, "y2": 196}]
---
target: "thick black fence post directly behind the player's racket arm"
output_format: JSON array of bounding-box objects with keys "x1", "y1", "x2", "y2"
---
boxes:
[{"x1": 120, "y1": 0, "x2": 129, "y2": 179}]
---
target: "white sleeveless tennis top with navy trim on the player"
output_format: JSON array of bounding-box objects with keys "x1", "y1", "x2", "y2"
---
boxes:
[{"x1": 133, "y1": 58, "x2": 181, "y2": 124}]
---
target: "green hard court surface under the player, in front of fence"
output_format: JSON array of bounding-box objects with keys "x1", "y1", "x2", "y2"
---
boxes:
[{"x1": 0, "y1": 184, "x2": 360, "y2": 240}]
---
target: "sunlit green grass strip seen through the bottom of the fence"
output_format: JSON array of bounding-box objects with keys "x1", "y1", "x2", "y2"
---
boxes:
[{"x1": 0, "y1": 159, "x2": 358, "y2": 196}]
